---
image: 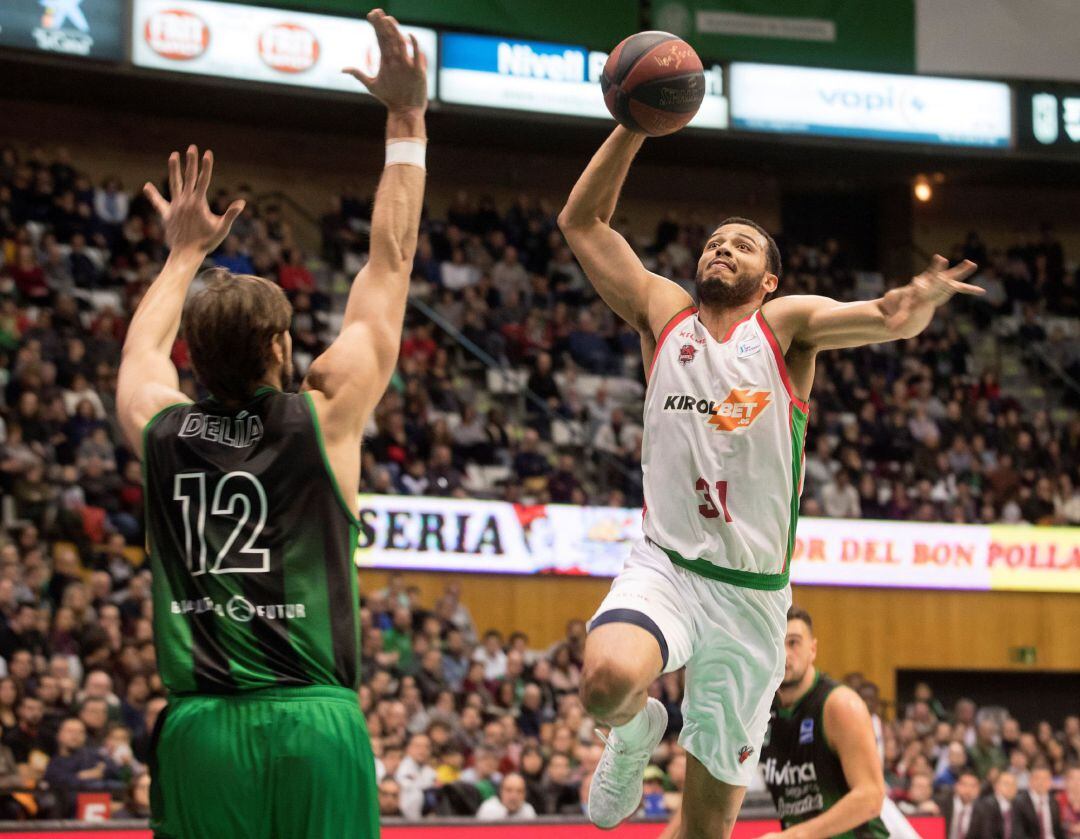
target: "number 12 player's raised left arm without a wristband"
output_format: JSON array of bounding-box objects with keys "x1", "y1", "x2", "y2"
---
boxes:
[{"x1": 117, "y1": 146, "x2": 244, "y2": 457}]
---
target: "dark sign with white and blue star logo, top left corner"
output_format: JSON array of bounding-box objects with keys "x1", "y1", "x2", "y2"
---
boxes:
[{"x1": 0, "y1": 0, "x2": 124, "y2": 62}]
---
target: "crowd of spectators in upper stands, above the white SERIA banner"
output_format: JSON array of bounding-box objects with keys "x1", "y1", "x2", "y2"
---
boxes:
[{"x1": 0, "y1": 148, "x2": 1080, "y2": 522}]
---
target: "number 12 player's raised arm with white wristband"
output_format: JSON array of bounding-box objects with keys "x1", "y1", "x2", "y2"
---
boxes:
[{"x1": 303, "y1": 9, "x2": 428, "y2": 442}]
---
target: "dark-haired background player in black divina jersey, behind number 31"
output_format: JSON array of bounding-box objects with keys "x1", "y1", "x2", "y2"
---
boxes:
[{"x1": 760, "y1": 607, "x2": 889, "y2": 839}]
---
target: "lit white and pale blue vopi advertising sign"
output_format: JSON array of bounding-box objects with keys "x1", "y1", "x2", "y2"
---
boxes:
[{"x1": 729, "y1": 63, "x2": 1012, "y2": 148}]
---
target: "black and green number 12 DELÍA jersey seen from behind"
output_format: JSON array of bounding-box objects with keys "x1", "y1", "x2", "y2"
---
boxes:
[{"x1": 143, "y1": 388, "x2": 360, "y2": 694}]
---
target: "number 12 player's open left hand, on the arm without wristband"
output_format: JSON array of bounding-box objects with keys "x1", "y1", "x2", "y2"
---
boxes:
[{"x1": 143, "y1": 146, "x2": 244, "y2": 254}]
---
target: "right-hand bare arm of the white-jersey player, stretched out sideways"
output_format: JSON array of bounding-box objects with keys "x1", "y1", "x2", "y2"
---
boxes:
[{"x1": 761, "y1": 256, "x2": 985, "y2": 351}]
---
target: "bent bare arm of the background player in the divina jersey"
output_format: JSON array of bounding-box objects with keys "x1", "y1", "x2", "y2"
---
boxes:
[{"x1": 760, "y1": 687, "x2": 886, "y2": 839}]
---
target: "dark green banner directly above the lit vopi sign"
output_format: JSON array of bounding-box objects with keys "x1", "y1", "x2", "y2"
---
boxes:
[{"x1": 650, "y1": 0, "x2": 915, "y2": 72}]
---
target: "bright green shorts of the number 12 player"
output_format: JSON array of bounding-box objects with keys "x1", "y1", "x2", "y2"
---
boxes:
[{"x1": 150, "y1": 686, "x2": 379, "y2": 839}]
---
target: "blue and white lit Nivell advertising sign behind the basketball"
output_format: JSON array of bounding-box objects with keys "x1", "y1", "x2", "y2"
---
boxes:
[{"x1": 438, "y1": 32, "x2": 728, "y2": 128}]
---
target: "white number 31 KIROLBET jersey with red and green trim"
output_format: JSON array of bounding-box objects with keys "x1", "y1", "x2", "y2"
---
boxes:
[{"x1": 642, "y1": 308, "x2": 809, "y2": 590}]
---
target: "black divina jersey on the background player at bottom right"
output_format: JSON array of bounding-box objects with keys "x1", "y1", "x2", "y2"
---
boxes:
[{"x1": 761, "y1": 673, "x2": 889, "y2": 839}]
